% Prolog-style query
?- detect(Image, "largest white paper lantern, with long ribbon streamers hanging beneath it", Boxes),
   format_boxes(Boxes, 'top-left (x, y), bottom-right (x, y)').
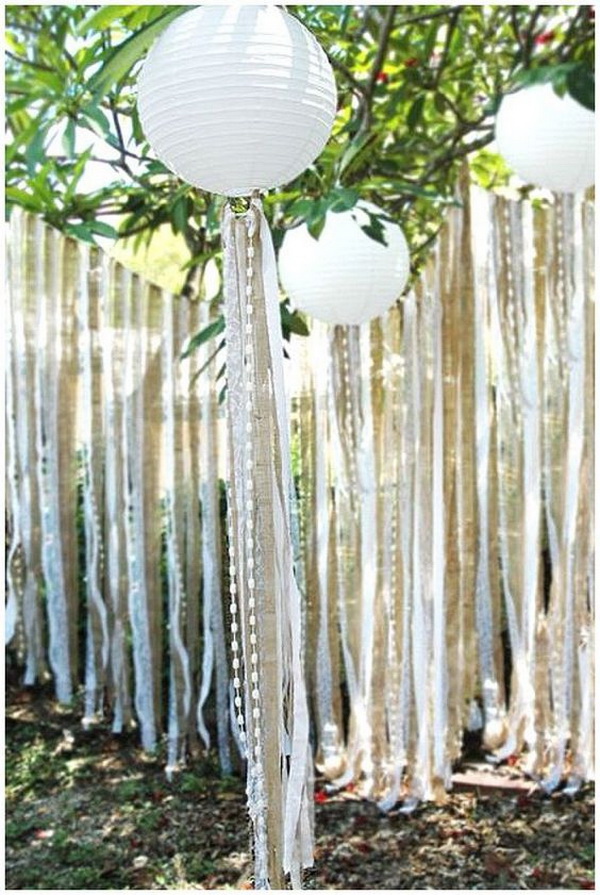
top-left (138, 5), bottom-right (336, 196)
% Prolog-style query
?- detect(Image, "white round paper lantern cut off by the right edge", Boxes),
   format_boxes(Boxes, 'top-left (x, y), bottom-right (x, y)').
top-left (496, 84), bottom-right (594, 193)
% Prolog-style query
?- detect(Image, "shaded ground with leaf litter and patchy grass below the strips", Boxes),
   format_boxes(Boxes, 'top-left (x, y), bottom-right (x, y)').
top-left (5, 687), bottom-right (594, 889)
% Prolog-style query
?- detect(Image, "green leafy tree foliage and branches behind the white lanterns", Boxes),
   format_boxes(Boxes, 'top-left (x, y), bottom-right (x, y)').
top-left (6, 5), bottom-right (594, 296)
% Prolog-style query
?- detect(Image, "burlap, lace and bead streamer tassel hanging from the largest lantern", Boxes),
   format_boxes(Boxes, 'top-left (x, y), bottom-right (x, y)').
top-left (223, 199), bottom-right (312, 888)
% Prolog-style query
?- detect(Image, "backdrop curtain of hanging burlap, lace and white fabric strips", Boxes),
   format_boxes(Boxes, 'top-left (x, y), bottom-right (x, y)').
top-left (6, 191), bottom-right (594, 811)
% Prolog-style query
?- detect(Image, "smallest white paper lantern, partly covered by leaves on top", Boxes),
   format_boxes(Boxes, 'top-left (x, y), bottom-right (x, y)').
top-left (279, 201), bottom-right (410, 325)
